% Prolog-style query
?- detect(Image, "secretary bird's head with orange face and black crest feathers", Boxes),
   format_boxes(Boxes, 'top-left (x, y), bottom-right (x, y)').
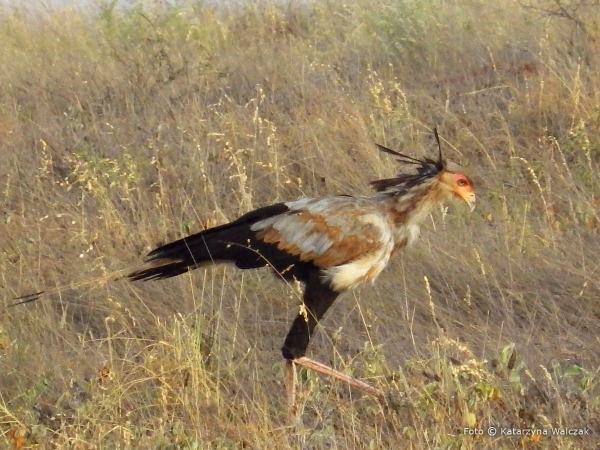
top-left (371, 129), bottom-right (476, 211)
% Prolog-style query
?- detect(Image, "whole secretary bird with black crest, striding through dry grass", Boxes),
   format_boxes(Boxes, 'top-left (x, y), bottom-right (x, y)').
top-left (11, 130), bottom-right (475, 411)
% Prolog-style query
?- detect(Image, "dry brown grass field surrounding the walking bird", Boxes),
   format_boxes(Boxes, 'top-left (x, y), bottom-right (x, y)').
top-left (0, 0), bottom-right (600, 450)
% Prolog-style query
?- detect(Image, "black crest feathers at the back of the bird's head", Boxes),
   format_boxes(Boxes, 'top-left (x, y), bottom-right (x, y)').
top-left (370, 128), bottom-right (445, 192)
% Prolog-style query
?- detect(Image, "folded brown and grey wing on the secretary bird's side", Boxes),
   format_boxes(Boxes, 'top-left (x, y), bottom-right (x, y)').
top-left (251, 196), bottom-right (393, 268)
